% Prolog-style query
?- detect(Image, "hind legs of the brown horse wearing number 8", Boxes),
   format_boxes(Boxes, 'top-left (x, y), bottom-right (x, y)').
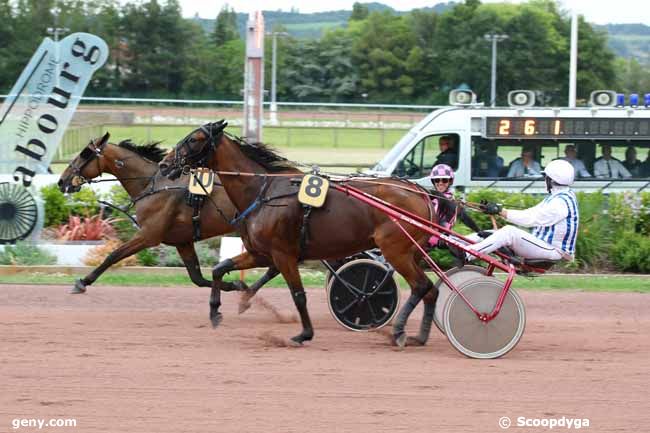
top-left (382, 248), bottom-right (438, 347)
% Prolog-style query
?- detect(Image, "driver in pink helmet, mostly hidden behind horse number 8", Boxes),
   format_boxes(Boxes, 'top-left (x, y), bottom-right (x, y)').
top-left (429, 164), bottom-right (481, 247)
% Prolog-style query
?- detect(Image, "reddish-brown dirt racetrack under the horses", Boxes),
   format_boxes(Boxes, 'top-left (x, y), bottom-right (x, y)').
top-left (0, 285), bottom-right (650, 433)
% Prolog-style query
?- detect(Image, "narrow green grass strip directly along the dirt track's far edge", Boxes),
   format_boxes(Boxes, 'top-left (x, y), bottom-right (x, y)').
top-left (2, 270), bottom-right (650, 293)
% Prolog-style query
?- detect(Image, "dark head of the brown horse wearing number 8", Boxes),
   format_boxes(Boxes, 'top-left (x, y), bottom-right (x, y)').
top-left (159, 120), bottom-right (228, 180)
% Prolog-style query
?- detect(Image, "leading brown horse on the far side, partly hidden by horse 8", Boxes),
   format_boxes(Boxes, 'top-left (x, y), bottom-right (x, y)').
top-left (58, 133), bottom-right (278, 322)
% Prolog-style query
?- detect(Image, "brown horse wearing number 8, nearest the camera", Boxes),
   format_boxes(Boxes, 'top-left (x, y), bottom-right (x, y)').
top-left (160, 121), bottom-right (438, 346)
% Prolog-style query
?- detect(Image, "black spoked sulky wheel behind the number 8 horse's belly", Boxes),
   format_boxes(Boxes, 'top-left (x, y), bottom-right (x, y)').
top-left (327, 259), bottom-right (399, 331)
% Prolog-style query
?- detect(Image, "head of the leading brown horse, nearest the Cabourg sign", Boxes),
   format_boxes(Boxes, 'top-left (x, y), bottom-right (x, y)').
top-left (58, 132), bottom-right (110, 193)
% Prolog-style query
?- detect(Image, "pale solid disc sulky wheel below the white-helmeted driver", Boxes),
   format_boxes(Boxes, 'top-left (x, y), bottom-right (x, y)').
top-left (444, 277), bottom-right (526, 359)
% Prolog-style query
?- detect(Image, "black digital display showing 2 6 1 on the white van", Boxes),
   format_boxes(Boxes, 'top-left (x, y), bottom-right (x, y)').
top-left (485, 117), bottom-right (650, 140)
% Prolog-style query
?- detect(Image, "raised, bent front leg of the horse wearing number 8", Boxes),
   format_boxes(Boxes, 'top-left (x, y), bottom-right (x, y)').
top-left (210, 252), bottom-right (268, 328)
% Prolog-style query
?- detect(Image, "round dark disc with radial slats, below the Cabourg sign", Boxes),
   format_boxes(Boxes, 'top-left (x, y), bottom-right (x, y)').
top-left (0, 182), bottom-right (38, 244)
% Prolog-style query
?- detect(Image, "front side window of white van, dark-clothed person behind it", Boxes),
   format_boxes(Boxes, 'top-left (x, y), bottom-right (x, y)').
top-left (394, 134), bottom-right (459, 179)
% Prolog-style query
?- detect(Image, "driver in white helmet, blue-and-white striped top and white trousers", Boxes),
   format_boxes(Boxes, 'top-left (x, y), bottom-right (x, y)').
top-left (466, 159), bottom-right (579, 261)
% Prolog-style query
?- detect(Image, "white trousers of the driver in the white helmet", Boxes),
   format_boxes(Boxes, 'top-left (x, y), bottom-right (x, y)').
top-left (467, 226), bottom-right (562, 260)
